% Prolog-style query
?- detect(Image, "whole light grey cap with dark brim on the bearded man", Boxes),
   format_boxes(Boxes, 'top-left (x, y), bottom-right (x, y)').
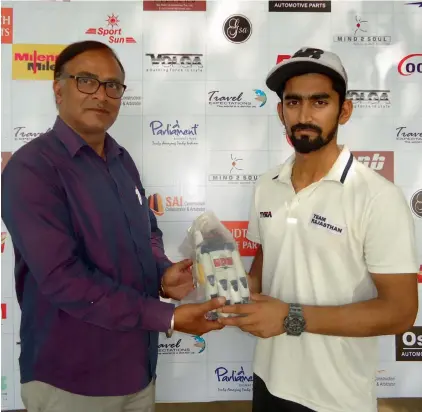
top-left (266, 47), bottom-right (347, 98)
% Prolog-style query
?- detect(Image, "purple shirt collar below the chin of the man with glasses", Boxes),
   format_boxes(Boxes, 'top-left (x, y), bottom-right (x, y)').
top-left (53, 116), bottom-right (123, 159)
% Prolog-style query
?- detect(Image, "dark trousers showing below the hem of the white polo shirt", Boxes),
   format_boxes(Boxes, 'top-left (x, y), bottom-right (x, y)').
top-left (252, 374), bottom-right (315, 412)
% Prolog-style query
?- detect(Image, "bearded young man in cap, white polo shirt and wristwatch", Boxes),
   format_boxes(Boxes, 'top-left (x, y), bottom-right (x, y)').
top-left (221, 48), bottom-right (418, 412)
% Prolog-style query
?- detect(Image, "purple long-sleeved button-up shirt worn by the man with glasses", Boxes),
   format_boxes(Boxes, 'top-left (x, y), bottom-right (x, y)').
top-left (1, 117), bottom-right (174, 396)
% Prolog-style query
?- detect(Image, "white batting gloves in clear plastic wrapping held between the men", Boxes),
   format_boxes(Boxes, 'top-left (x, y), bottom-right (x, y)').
top-left (188, 211), bottom-right (250, 317)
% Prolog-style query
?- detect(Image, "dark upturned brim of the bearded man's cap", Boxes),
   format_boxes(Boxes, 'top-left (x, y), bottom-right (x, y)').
top-left (266, 61), bottom-right (346, 94)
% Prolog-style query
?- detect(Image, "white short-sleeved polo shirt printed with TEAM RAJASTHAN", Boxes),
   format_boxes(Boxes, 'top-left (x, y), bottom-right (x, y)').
top-left (247, 147), bottom-right (419, 412)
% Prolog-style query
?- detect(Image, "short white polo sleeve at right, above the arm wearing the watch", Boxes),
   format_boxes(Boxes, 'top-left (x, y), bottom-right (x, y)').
top-left (364, 185), bottom-right (419, 274)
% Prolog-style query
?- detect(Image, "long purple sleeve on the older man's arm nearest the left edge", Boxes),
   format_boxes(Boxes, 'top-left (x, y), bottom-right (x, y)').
top-left (1, 159), bottom-right (174, 332)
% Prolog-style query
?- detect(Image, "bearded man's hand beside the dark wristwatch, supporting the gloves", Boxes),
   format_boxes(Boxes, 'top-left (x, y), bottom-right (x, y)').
top-left (218, 293), bottom-right (289, 338)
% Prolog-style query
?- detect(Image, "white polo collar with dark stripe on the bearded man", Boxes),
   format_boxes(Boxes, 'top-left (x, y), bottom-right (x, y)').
top-left (273, 145), bottom-right (353, 184)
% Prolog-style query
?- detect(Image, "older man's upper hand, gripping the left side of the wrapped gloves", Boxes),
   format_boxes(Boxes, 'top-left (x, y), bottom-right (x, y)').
top-left (163, 259), bottom-right (194, 300)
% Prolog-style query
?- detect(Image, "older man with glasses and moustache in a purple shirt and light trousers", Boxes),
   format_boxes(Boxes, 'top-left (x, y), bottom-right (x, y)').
top-left (2, 41), bottom-right (224, 412)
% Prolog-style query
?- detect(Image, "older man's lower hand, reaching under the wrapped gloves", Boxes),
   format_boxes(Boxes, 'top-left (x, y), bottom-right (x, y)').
top-left (174, 297), bottom-right (226, 336)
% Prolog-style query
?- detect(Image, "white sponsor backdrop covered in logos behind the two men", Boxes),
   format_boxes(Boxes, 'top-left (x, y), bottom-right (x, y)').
top-left (1, 0), bottom-right (422, 409)
